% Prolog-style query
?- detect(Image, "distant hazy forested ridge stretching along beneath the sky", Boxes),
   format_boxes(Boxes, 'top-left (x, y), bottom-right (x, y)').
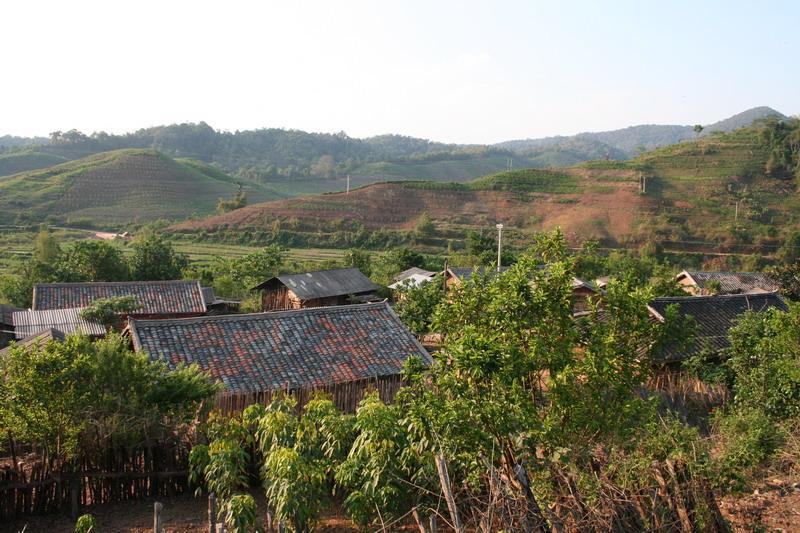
top-left (0, 107), bottom-right (783, 183)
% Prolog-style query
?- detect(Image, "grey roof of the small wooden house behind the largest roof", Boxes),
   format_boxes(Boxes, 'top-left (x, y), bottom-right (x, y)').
top-left (253, 268), bottom-right (380, 300)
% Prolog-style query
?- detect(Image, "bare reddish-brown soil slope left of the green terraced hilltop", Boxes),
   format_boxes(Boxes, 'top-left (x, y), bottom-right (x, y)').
top-left (173, 168), bottom-right (648, 240)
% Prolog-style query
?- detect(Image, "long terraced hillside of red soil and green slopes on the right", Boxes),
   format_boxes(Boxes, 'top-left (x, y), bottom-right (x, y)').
top-left (174, 119), bottom-right (800, 255)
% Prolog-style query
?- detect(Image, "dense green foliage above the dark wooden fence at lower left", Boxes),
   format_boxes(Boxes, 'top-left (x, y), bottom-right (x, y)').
top-left (0, 333), bottom-right (218, 461)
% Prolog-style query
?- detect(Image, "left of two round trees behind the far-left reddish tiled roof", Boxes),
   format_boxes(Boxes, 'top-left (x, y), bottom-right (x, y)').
top-left (56, 240), bottom-right (128, 282)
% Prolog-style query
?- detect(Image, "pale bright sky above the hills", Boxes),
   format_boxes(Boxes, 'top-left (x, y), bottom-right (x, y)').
top-left (0, 0), bottom-right (800, 143)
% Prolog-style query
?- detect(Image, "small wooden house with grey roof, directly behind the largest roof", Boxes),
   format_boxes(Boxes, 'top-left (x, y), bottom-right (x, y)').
top-left (252, 268), bottom-right (380, 311)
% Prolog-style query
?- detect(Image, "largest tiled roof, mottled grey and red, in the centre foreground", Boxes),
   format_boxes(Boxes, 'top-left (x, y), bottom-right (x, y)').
top-left (130, 302), bottom-right (431, 392)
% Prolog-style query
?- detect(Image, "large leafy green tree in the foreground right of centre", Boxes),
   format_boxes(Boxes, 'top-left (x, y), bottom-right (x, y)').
top-left (398, 232), bottom-right (660, 530)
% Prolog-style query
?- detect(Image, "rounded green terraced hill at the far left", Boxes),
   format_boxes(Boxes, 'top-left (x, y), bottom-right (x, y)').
top-left (0, 150), bottom-right (278, 227)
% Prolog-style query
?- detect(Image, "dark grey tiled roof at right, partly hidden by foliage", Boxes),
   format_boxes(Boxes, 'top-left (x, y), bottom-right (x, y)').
top-left (648, 293), bottom-right (788, 360)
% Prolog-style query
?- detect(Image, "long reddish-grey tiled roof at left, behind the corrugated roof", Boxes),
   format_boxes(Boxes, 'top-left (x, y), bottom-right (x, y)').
top-left (33, 280), bottom-right (206, 315)
